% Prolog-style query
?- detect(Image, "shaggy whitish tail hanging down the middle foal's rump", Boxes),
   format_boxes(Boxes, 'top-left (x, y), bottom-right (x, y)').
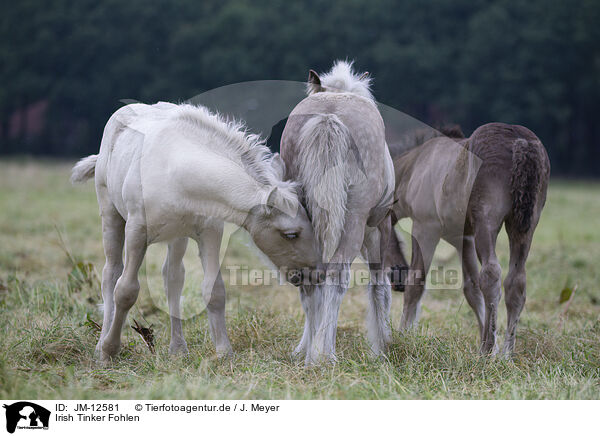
top-left (298, 114), bottom-right (351, 262)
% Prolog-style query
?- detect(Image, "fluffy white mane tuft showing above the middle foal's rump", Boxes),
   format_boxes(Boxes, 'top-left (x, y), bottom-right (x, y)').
top-left (307, 60), bottom-right (374, 100)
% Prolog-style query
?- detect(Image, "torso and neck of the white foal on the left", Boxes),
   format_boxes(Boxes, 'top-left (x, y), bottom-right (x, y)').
top-left (96, 102), bottom-right (267, 241)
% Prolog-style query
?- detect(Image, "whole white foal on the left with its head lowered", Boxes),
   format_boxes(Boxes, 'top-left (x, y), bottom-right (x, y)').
top-left (71, 103), bottom-right (321, 361)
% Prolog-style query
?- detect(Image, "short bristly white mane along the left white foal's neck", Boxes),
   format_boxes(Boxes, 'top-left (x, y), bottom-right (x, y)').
top-left (166, 103), bottom-right (297, 204)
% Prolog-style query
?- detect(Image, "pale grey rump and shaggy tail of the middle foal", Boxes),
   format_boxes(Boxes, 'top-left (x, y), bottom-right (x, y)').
top-left (282, 93), bottom-right (394, 259)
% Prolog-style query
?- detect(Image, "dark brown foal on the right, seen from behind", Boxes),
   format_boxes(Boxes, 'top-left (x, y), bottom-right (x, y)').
top-left (388, 123), bottom-right (550, 355)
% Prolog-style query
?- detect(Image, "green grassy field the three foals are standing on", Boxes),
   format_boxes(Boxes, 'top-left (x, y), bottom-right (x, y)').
top-left (0, 161), bottom-right (600, 399)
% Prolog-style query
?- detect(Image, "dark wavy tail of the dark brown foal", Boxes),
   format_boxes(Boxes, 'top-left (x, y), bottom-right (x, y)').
top-left (510, 138), bottom-right (543, 233)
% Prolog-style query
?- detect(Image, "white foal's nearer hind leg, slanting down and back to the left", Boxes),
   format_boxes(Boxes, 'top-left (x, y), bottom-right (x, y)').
top-left (102, 217), bottom-right (147, 361)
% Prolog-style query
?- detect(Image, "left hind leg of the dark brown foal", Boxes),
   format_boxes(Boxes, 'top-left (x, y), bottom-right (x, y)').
top-left (475, 221), bottom-right (502, 355)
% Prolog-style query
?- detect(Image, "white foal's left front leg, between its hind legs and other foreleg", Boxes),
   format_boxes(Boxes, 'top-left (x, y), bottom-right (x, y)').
top-left (162, 238), bottom-right (188, 354)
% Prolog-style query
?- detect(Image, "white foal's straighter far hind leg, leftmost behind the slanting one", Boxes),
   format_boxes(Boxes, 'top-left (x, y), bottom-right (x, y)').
top-left (96, 205), bottom-right (125, 357)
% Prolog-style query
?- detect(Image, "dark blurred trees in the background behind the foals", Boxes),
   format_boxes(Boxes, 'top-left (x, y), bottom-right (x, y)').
top-left (0, 0), bottom-right (600, 176)
